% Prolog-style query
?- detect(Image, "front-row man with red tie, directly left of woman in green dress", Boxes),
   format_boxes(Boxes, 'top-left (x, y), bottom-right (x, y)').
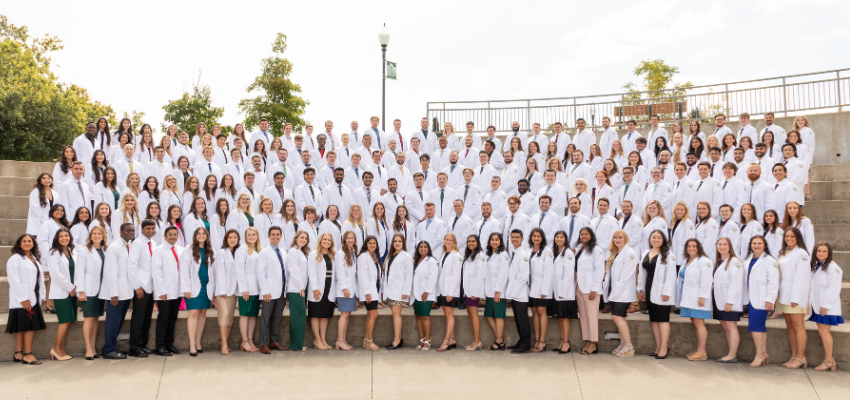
top-left (151, 226), bottom-right (183, 356)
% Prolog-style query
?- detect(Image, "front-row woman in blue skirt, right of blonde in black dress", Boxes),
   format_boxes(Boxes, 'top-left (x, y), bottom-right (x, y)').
top-left (334, 231), bottom-right (359, 350)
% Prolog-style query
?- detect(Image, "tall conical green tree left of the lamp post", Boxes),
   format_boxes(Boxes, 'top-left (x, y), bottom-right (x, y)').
top-left (239, 33), bottom-right (310, 135)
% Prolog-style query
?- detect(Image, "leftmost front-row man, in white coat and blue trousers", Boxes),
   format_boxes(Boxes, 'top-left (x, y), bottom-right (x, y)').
top-left (98, 222), bottom-right (135, 360)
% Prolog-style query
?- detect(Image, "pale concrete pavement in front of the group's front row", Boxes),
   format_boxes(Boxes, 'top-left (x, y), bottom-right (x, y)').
top-left (0, 347), bottom-right (850, 400)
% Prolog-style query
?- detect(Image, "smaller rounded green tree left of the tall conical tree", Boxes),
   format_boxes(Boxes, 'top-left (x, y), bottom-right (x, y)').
top-left (161, 78), bottom-right (231, 137)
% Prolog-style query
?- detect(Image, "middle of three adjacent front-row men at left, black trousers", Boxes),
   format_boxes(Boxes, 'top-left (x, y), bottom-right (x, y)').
top-left (127, 219), bottom-right (156, 357)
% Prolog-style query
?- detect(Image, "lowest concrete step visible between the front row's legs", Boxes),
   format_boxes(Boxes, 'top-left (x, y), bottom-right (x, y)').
top-left (0, 307), bottom-right (850, 362)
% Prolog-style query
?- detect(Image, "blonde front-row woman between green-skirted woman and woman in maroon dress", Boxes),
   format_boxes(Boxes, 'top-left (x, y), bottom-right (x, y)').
top-left (437, 233), bottom-right (464, 351)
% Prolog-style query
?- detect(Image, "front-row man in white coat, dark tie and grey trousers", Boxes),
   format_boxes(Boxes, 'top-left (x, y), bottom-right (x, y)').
top-left (257, 226), bottom-right (288, 354)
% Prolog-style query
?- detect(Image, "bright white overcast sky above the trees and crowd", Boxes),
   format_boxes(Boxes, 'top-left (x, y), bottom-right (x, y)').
top-left (6, 0), bottom-right (850, 139)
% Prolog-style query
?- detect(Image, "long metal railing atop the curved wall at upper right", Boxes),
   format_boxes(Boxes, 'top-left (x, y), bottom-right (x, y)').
top-left (426, 68), bottom-right (850, 132)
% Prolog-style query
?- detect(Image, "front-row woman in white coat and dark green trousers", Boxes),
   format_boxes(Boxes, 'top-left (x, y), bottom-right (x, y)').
top-left (286, 231), bottom-right (310, 351)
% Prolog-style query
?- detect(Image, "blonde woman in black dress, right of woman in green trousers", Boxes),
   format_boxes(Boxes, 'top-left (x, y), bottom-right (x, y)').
top-left (307, 233), bottom-right (336, 350)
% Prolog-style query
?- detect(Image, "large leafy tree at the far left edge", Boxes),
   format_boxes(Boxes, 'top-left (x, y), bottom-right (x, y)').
top-left (0, 15), bottom-right (115, 161)
